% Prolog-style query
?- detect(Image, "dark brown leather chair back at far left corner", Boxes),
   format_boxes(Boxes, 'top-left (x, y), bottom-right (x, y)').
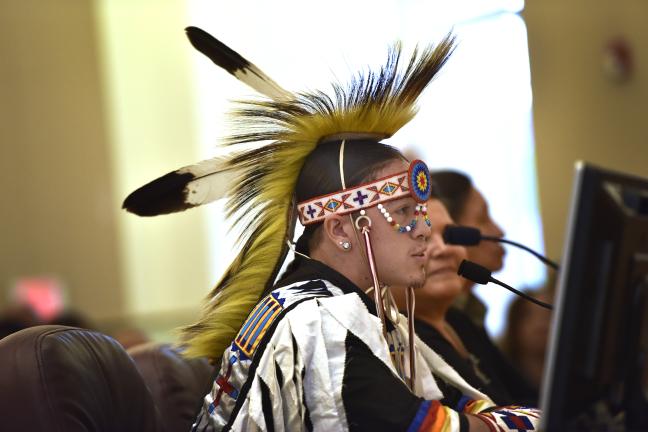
top-left (0, 326), bottom-right (163, 432)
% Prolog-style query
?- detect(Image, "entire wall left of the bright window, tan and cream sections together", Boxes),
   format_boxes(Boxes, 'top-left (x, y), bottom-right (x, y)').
top-left (0, 0), bottom-right (213, 339)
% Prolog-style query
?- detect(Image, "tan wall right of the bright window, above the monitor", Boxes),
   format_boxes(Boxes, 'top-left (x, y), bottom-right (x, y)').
top-left (524, 0), bottom-right (648, 257)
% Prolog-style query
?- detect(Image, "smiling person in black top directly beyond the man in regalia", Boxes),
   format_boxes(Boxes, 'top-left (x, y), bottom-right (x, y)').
top-left (391, 199), bottom-right (538, 406)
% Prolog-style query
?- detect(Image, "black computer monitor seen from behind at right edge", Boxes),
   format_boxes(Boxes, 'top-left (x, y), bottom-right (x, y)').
top-left (540, 162), bottom-right (648, 431)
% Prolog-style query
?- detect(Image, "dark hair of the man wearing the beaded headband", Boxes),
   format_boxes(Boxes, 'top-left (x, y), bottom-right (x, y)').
top-left (281, 140), bottom-right (404, 279)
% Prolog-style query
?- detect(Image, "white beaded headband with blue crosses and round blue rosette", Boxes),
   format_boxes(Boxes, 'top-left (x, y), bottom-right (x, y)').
top-left (297, 159), bottom-right (431, 225)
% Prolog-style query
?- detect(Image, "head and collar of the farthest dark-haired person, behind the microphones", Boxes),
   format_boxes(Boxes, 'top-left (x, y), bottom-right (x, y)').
top-left (432, 170), bottom-right (506, 327)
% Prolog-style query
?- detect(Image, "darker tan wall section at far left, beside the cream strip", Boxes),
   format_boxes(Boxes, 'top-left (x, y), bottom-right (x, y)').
top-left (0, 0), bottom-right (125, 319)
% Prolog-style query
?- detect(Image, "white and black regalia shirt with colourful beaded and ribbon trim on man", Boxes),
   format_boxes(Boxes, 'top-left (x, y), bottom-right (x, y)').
top-left (193, 260), bottom-right (536, 432)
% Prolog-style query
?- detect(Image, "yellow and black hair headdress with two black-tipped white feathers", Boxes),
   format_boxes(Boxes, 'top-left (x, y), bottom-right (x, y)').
top-left (124, 27), bottom-right (454, 358)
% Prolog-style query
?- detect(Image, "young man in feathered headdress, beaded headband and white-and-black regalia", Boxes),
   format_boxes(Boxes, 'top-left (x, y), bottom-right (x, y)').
top-left (124, 28), bottom-right (538, 431)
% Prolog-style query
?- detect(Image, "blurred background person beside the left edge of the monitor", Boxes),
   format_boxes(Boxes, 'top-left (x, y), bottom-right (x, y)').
top-left (499, 278), bottom-right (554, 391)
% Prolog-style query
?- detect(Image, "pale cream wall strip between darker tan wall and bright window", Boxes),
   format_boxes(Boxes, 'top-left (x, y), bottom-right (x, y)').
top-left (95, 0), bottom-right (215, 336)
